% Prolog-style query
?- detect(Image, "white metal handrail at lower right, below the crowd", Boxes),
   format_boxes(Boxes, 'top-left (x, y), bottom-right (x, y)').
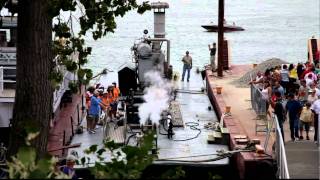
top-left (272, 113), bottom-right (290, 179)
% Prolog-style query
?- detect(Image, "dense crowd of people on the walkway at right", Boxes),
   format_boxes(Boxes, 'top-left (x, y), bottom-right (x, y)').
top-left (249, 61), bottom-right (320, 143)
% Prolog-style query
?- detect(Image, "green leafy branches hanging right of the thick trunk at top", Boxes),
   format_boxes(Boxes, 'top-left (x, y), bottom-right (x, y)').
top-left (48, 0), bottom-right (151, 90)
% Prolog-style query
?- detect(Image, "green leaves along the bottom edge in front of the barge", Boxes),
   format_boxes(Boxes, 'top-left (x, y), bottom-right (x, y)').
top-left (6, 131), bottom-right (185, 179)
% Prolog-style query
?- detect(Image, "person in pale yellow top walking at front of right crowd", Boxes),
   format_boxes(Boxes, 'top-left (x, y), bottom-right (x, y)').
top-left (299, 102), bottom-right (313, 140)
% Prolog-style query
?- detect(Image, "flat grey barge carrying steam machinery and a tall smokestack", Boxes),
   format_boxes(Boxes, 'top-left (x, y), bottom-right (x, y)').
top-left (68, 2), bottom-right (236, 178)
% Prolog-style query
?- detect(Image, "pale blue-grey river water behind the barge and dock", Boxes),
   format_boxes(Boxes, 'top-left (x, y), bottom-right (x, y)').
top-left (81, 0), bottom-right (320, 73)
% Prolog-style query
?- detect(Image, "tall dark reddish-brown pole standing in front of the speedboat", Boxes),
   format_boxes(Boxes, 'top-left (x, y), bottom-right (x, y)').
top-left (218, 0), bottom-right (224, 77)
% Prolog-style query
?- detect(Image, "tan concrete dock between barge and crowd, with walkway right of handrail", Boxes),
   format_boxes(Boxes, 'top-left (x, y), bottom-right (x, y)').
top-left (206, 65), bottom-right (319, 179)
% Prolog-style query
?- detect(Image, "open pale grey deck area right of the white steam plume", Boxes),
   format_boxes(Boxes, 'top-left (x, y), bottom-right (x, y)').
top-left (156, 71), bottom-right (230, 167)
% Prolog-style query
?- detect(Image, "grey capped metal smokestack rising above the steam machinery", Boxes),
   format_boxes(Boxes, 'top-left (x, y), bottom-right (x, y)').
top-left (151, 1), bottom-right (169, 38)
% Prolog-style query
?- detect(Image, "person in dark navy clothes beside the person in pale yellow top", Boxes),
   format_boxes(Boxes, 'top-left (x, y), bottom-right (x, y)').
top-left (286, 93), bottom-right (302, 141)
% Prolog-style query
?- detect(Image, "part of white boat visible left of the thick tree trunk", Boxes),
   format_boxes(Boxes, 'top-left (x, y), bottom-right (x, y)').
top-left (0, 16), bottom-right (17, 148)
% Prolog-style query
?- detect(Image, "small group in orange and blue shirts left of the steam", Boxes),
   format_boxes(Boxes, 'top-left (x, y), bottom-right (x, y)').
top-left (86, 82), bottom-right (120, 134)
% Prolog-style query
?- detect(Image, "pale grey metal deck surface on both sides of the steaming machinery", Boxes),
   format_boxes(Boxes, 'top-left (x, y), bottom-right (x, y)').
top-left (69, 70), bottom-right (229, 167)
